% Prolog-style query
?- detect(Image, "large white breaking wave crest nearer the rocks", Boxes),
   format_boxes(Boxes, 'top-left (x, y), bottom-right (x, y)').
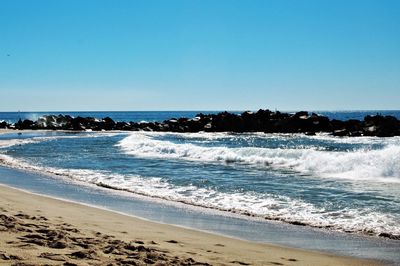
top-left (117, 132), bottom-right (400, 183)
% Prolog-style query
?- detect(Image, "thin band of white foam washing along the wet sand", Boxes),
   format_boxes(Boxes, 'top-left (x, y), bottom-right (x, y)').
top-left (0, 154), bottom-right (400, 235)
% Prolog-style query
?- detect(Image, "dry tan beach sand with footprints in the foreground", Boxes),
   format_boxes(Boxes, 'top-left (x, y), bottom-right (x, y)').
top-left (0, 185), bottom-right (377, 265)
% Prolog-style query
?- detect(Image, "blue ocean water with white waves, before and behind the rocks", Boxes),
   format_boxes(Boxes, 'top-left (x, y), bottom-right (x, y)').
top-left (0, 111), bottom-right (400, 262)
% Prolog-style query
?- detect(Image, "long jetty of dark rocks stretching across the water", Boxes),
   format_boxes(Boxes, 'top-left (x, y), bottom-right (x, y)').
top-left (0, 109), bottom-right (400, 137)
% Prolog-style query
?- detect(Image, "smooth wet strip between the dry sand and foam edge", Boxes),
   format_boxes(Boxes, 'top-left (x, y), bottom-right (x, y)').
top-left (0, 167), bottom-right (400, 265)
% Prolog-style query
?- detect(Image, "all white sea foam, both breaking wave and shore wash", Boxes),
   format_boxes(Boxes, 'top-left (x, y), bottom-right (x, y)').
top-left (0, 132), bottom-right (400, 238)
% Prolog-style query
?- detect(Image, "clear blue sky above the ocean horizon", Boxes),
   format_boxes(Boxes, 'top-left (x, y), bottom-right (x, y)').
top-left (0, 0), bottom-right (400, 111)
